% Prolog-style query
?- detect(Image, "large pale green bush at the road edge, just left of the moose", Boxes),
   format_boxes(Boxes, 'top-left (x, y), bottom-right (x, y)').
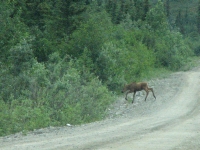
top-left (45, 53), bottom-right (113, 124)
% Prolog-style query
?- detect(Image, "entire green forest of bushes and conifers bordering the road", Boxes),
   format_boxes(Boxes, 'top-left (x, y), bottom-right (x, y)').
top-left (0, 0), bottom-right (200, 136)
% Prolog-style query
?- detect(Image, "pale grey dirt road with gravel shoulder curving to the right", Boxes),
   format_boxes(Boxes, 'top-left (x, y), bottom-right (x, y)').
top-left (0, 68), bottom-right (200, 150)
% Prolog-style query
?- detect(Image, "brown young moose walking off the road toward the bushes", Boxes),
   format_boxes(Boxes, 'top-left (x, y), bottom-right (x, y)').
top-left (122, 82), bottom-right (156, 103)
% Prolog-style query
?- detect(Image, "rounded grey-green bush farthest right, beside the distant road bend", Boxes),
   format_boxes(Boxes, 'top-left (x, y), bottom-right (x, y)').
top-left (155, 31), bottom-right (193, 70)
